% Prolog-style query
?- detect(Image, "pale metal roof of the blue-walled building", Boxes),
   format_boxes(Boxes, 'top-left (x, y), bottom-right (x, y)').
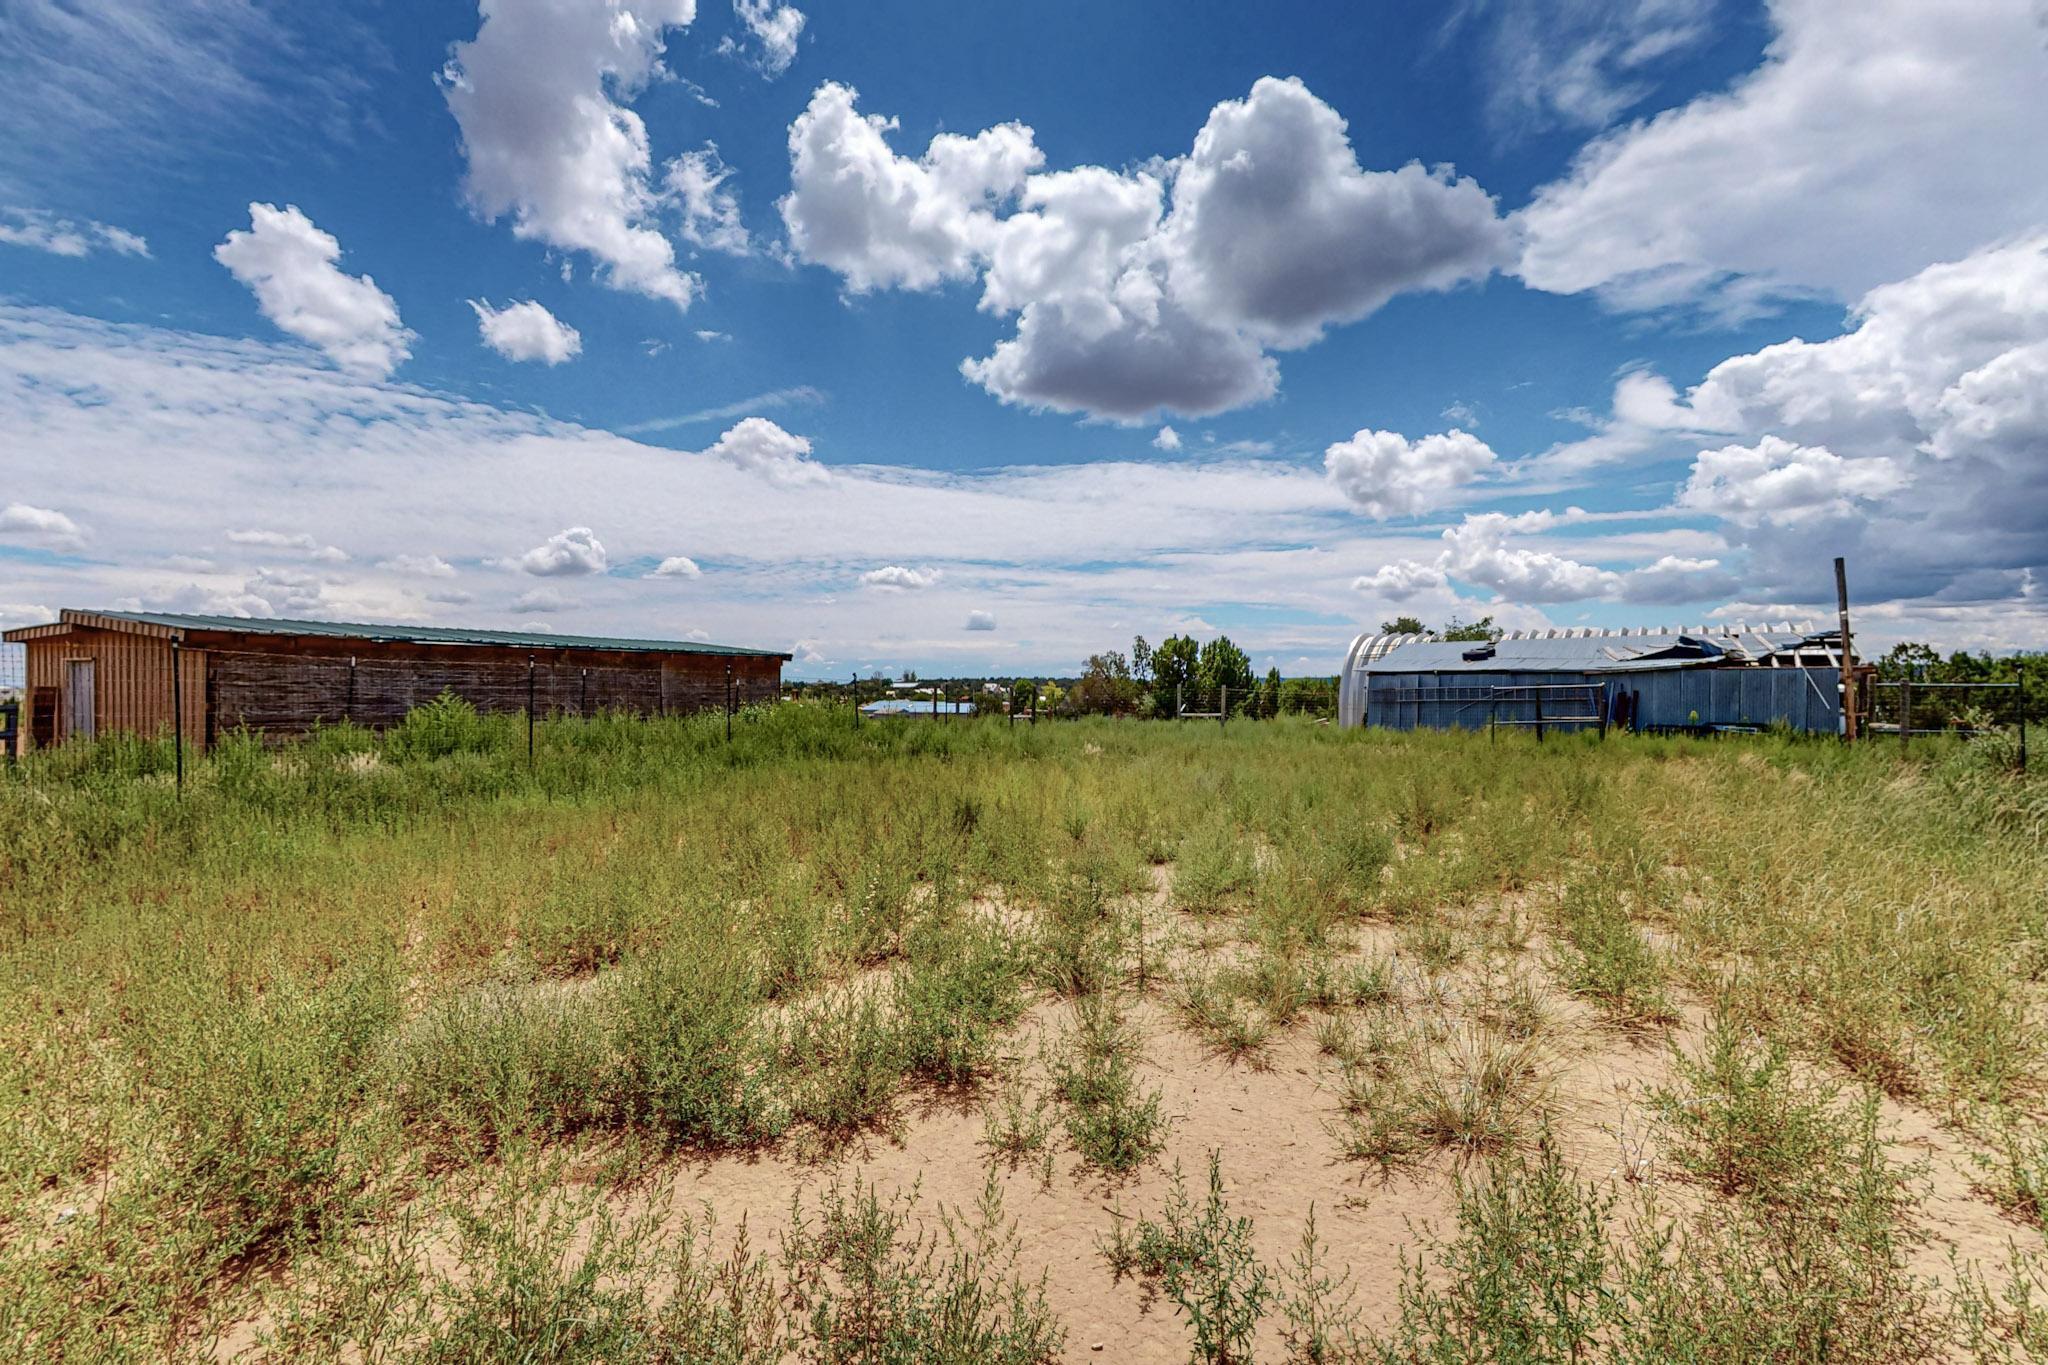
top-left (1364, 630), bottom-right (1806, 675)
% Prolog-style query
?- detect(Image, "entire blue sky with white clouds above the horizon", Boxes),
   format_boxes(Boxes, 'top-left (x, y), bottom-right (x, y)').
top-left (0, 0), bottom-right (2048, 675)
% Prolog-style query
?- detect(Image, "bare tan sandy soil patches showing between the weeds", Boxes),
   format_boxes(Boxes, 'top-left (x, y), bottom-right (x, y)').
top-left (207, 886), bottom-right (2019, 1363)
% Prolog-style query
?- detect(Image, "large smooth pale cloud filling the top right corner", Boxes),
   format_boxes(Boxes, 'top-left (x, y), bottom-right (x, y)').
top-left (1518, 0), bottom-right (2048, 311)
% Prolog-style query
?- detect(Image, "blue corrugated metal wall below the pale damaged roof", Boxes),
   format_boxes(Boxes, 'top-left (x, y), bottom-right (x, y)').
top-left (1366, 667), bottom-right (1841, 735)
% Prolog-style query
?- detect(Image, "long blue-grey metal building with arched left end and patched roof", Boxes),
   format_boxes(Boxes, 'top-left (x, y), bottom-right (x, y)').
top-left (1337, 624), bottom-right (1841, 735)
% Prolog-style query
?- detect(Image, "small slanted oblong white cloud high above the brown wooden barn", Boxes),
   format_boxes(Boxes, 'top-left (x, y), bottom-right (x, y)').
top-left (213, 205), bottom-right (414, 379)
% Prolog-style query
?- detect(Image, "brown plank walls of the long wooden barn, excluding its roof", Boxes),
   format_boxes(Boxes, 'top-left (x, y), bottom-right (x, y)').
top-left (10, 620), bottom-right (782, 749)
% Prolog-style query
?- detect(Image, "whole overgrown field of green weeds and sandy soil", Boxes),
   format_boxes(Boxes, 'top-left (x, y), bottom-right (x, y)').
top-left (0, 704), bottom-right (2048, 1365)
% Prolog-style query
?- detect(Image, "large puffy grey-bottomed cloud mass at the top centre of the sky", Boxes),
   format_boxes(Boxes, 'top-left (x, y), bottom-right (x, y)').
top-left (780, 78), bottom-right (1507, 422)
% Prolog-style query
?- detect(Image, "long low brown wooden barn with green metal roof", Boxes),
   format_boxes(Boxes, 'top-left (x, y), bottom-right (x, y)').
top-left (4, 610), bottom-right (788, 749)
